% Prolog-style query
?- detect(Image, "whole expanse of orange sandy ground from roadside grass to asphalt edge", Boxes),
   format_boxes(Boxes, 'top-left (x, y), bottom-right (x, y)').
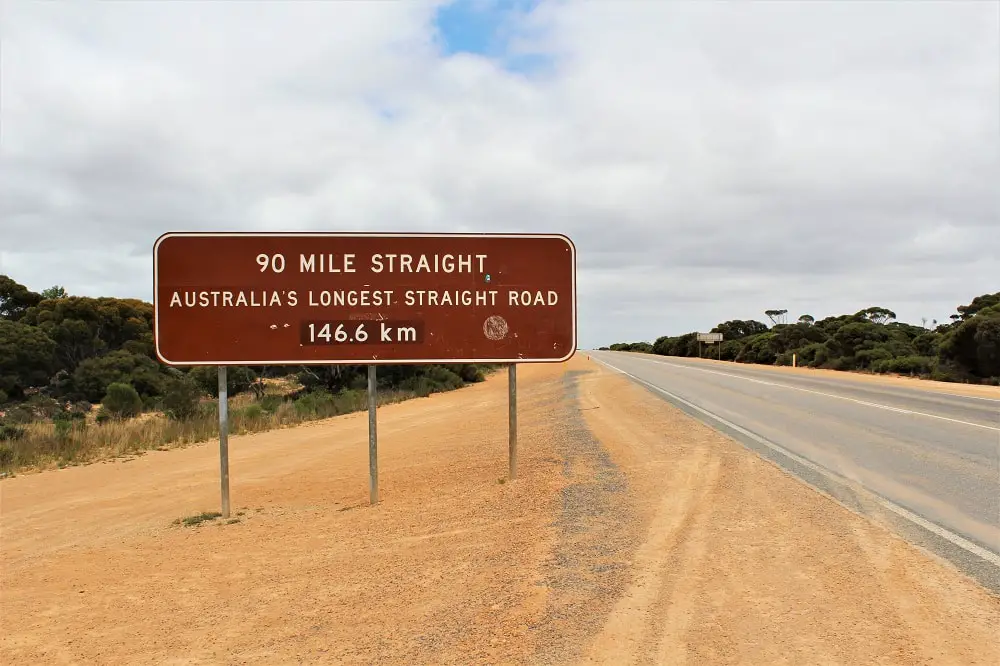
top-left (0, 356), bottom-right (1000, 665)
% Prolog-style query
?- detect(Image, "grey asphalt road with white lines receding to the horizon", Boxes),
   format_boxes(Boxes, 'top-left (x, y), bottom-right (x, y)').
top-left (591, 352), bottom-right (1000, 578)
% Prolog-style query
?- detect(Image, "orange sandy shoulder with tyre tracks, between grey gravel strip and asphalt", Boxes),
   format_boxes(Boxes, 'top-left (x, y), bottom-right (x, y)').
top-left (580, 364), bottom-right (1000, 664)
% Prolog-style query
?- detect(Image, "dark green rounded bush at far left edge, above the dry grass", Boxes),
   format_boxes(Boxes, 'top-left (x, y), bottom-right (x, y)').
top-left (0, 319), bottom-right (56, 400)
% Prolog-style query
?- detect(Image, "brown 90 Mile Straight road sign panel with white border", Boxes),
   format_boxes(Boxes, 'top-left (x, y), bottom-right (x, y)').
top-left (153, 233), bottom-right (576, 365)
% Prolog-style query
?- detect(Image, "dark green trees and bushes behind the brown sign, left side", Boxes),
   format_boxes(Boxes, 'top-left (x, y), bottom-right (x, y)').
top-left (0, 275), bottom-right (490, 418)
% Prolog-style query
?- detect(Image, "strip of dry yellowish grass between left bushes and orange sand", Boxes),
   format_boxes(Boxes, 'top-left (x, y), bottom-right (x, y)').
top-left (0, 384), bottom-right (426, 474)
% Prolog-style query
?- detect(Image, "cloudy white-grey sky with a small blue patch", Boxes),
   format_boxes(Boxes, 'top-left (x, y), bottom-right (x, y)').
top-left (0, 0), bottom-right (1000, 349)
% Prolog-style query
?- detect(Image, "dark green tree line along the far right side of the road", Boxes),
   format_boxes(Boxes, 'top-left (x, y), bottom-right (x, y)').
top-left (602, 292), bottom-right (1000, 385)
